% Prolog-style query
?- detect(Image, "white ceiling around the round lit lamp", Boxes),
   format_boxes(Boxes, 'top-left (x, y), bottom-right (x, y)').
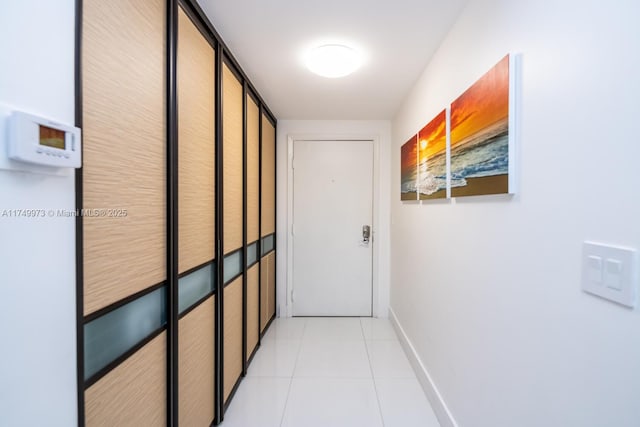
top-left (198, 0), bottom-right (467, 120)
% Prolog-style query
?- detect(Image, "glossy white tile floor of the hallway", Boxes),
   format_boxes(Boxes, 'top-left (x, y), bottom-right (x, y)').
top-left (221, 317), bottom-right (439, 427)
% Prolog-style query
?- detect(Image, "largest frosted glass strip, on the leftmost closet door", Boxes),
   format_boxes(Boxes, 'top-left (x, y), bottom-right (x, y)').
top-left (84, 286), bottom-right (167, 380)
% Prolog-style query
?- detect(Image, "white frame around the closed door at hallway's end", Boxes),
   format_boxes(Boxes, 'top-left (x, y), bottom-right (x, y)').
top-left (280, 133), bottom-right (386, 317)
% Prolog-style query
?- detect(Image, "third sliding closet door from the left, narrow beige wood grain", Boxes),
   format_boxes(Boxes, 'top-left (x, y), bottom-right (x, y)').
top-left (222, 63), bottom-right (244, 403)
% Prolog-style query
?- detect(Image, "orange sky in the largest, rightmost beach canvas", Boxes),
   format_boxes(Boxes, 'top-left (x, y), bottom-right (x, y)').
top-left (451, 56), bottom-right (509, 147)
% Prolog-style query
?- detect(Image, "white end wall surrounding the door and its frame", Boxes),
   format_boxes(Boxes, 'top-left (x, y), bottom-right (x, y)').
top-left (276, 120), bottom-right (391, 317)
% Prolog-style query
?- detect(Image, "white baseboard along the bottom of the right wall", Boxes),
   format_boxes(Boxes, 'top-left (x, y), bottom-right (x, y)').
top-left (389, 307), bottom-right (458, 427)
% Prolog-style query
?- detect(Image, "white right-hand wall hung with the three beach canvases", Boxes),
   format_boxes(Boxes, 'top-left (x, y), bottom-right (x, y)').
top-left (391, 0), bottom-right (640, 427)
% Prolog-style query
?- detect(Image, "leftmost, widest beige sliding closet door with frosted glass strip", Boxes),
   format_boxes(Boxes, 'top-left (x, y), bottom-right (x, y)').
top-left (81, 0), bottom-right (167, 426)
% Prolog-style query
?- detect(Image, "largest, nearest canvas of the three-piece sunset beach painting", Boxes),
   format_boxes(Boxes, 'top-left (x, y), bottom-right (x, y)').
top-left (451, 55), bottom-right (513, 197)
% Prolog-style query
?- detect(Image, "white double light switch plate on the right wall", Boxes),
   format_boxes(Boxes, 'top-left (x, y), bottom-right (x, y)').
top-left (582, 242), bottom-right (638, 308)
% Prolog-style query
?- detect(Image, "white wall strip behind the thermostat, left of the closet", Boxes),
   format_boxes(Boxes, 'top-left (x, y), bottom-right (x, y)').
top-left (0, 0), bottom-right (77, 427)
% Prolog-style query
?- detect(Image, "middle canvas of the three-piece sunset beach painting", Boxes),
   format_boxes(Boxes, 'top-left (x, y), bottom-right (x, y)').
top-left (417, 110), bottom-right (447, 200)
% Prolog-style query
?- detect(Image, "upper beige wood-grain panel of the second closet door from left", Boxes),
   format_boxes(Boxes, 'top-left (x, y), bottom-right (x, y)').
top-left (178, 9), bottom-right (215, 273)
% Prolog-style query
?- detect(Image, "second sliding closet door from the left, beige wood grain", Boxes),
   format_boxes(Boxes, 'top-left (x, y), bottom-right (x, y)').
top-left (177, 9), bottom-right (215, 427)
